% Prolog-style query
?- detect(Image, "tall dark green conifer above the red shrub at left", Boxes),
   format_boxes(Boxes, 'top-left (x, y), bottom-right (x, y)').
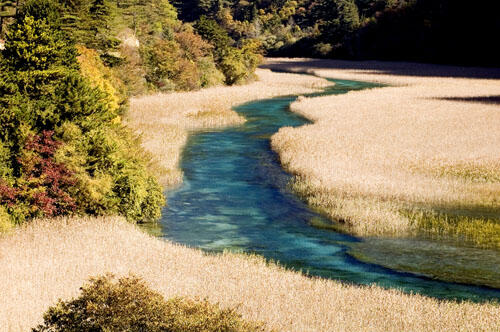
top-left (0, 0), bottom-right (113, 147)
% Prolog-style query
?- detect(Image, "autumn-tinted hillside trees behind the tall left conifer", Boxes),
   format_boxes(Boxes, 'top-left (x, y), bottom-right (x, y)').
top-left (0, 0), bottom-right (262, 94)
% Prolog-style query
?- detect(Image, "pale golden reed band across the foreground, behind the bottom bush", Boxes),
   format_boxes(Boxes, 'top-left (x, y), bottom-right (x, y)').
top-left (0, 218), bottom-right (500, 332)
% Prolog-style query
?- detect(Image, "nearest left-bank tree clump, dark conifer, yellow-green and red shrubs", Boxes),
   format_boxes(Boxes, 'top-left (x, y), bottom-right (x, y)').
top-left (0, 0), bottom-right (164, 228)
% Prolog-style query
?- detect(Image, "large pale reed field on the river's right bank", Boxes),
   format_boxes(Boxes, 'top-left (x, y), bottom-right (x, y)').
top-left (266, 59), bottom-right (500, 248)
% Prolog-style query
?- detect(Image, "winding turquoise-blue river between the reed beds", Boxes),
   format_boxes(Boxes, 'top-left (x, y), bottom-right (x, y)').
top-left (161, 80), bottom-right (500, 301)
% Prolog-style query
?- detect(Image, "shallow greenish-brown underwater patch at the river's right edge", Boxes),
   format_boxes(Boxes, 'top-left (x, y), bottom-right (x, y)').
top-left (349, 238), bottom-right (500, 288)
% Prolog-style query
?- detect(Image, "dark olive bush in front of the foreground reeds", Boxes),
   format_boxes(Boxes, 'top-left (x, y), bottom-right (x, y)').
top-left (32, 275), bottom-right (264, 332)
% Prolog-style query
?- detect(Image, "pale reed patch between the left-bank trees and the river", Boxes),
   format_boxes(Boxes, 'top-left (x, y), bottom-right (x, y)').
top-left (127, 69), bottom-right (330, 186)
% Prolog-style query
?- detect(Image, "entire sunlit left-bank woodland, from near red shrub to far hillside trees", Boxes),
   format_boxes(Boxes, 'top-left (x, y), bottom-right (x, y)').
top-left (0, 0), bottom-right (261, 229)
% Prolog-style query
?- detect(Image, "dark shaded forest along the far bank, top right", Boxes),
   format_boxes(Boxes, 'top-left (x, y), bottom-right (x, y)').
top-left (174, 0), bottom-right (500, 66)
